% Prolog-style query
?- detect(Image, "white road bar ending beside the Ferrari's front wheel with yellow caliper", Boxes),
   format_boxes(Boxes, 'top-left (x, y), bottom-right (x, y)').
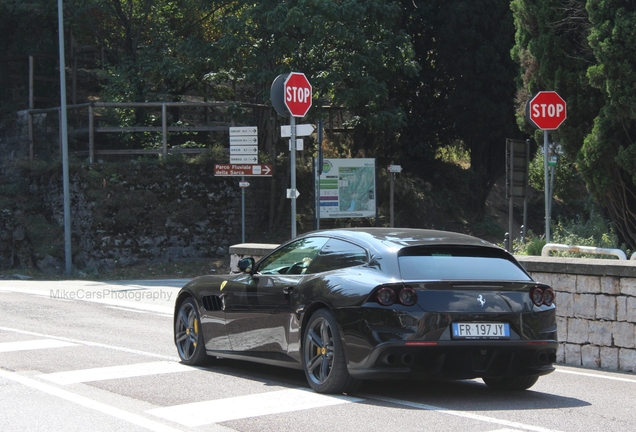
top-left (37, 361), bottom-right (197, 385)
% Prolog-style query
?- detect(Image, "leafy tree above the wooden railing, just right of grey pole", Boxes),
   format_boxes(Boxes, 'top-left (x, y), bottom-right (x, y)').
top-left (69, 0), bottom-right (222, 101)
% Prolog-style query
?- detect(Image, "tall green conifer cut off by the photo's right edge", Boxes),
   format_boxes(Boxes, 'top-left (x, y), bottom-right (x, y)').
top-left (580, 0), bottom-right (636, 248)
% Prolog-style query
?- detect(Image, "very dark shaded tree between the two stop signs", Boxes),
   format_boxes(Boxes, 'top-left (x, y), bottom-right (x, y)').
top-left (402, 0), bottom-right (518, 214)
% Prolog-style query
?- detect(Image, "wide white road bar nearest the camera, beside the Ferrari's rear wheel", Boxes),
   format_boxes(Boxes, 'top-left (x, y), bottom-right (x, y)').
top-left (146, 389), bottom-right (363, 427)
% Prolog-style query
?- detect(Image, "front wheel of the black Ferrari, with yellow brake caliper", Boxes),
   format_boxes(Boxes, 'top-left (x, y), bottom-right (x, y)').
top-left (174, 297), bottom-right (207, 366)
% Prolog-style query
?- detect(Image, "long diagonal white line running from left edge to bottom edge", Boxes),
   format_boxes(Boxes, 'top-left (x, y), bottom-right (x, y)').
top-left (0, 369), bottom-right (191, 432)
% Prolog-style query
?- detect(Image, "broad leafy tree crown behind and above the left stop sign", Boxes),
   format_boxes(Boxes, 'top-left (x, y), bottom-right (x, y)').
top-left (215, 0), bottom-right (417, 156)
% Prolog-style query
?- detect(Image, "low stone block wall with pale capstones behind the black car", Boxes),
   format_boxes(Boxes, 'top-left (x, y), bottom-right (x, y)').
top-left (230, 244), bottom-right (636, 372)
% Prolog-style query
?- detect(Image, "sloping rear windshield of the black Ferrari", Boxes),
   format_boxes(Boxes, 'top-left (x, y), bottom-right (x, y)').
top-left (398, 246), bottom-right (531, 281)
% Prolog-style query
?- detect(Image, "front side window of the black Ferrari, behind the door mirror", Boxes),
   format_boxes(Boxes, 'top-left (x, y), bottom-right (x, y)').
top-left (257, 237), bottom-right (329, 274)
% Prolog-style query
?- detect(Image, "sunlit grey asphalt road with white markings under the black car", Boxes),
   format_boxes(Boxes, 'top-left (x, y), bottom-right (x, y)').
top-left (0, 280), bottom-right (636, 432)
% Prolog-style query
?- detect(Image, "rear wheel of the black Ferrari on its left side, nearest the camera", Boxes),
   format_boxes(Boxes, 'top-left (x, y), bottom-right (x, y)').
top-left (302, 309), bottom-right (361, 394)
